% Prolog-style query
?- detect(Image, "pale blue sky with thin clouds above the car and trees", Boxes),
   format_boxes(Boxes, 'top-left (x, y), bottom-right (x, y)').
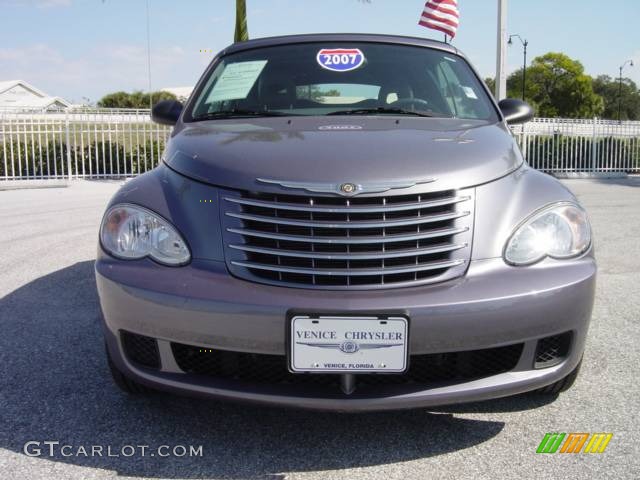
top-left (0, 0), bottom-right (640, 103)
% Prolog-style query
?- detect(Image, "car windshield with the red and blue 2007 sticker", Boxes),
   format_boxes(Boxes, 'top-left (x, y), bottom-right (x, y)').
top-left (186, 42), bottom-right (497, 121)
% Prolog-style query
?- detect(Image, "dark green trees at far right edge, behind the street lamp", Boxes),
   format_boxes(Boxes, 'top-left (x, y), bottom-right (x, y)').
top-left (593, 75), bottom-right (640, 120)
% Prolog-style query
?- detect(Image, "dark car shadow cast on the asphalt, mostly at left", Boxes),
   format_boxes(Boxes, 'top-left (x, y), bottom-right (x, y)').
top-left (0, 262), bottom-right (543, 479)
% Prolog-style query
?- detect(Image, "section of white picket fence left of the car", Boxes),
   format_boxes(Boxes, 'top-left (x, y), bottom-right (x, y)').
top-left (0, 109), bottom-right (171, 180)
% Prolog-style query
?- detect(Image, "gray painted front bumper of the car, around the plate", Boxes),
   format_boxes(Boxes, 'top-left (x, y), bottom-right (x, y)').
top-left (96, 253), bottom-right (596, 411)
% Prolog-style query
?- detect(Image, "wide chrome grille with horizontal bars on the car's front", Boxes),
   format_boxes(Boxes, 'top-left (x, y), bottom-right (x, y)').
top-left (222, 190), bottom-right (474, 289)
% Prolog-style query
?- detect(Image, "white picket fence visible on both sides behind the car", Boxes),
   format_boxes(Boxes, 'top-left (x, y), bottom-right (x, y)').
top-left (0, 109), bottom-right (640, 181)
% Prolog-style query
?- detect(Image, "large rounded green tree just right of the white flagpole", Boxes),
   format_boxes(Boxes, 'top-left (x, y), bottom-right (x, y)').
top-left (507, 52), bottom-right (604, 118)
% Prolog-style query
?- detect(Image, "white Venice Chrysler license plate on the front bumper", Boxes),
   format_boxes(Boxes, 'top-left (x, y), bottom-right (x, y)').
top-left (290, 316), bottom-right (409, 373)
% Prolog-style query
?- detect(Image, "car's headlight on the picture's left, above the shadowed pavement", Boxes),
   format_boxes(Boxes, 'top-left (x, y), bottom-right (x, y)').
top-left (100, 205), bottom-right (191, 266)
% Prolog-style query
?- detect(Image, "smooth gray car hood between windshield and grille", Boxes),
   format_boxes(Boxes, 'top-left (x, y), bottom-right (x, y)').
top-left (164, 116), bottom-right (523, 193)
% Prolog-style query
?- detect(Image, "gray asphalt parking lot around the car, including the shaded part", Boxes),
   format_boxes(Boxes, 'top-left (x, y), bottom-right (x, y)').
top-left (0, 178), bottom-right (640, 479)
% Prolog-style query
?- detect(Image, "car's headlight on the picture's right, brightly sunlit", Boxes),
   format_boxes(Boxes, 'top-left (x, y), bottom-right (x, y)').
top-left (504, 203), bottom-right (591, 265)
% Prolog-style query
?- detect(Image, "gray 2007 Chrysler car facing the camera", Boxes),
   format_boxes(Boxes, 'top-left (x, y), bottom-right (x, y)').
top-left (95, 34), bottom-right (596, 411)
